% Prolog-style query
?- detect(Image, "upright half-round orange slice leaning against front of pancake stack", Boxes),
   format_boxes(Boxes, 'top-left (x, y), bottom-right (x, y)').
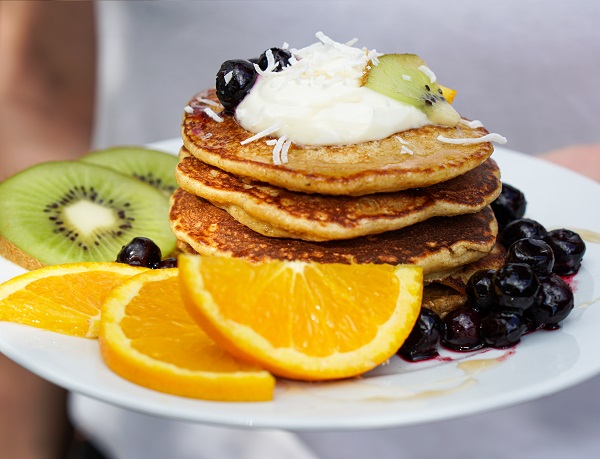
top-left (179, 255), bottom-right (423, 380)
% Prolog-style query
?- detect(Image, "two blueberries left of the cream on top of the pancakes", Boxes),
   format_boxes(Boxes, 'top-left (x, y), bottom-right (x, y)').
top-left (216, 48), bottom-right (292, 112)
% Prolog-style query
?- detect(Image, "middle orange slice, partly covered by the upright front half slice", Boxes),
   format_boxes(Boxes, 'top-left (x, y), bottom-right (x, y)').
top-left (99, 269), bottom-right (275, 401)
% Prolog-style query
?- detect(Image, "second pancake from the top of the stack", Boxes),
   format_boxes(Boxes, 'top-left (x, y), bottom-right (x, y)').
top-left (175, 148), bottom-right (502, 241)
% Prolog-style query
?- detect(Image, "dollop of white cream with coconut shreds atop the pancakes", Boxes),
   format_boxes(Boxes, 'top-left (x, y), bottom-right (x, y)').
top-left (235, 32), bottom-right (431, 145)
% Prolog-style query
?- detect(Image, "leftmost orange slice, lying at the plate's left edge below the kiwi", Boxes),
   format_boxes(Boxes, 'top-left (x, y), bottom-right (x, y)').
top-left (0, 262), bottom-right (147, 338)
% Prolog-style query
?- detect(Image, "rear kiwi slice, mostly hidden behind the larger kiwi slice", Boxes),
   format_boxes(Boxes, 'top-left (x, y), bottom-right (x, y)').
top-left (81, 146), bottom-right (178, 196)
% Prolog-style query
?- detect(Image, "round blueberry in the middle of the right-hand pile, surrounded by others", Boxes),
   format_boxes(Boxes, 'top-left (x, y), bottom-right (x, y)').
top-left (492, 263), bottom-right (539, 311)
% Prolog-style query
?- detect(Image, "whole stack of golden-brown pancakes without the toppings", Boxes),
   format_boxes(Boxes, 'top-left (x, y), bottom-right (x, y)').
top-left (170, 91), bottom-right (504, 315)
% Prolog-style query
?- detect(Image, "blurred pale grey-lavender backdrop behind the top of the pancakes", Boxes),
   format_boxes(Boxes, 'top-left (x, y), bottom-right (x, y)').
top-left (95, 0), bottom-right (600, 153)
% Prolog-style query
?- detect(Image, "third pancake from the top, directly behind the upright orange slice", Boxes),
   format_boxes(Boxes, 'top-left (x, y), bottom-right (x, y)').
top-left (169, 189), bottom-right (497, 274)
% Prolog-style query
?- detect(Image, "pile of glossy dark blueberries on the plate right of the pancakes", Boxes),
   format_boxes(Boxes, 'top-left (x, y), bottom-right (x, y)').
top-left (398, 184), bottom-right (585, 361)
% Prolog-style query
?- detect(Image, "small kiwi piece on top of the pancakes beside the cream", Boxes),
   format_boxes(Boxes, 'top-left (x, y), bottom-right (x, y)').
top-left (363, 54), bottom-right (460, 126)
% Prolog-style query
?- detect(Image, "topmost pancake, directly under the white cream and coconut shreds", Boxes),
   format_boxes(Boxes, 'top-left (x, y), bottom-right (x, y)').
top-left (182, 91), bottom-right (493, 196)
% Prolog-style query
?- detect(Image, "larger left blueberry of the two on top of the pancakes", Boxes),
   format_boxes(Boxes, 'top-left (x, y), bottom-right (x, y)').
top-left (216, 59), bottom-right (257, 111)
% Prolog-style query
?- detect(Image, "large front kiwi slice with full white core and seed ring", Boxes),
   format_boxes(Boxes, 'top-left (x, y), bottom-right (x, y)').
top-left (0, 161), bottom-right (176, 265)
